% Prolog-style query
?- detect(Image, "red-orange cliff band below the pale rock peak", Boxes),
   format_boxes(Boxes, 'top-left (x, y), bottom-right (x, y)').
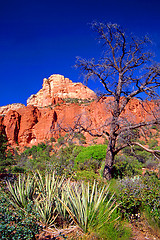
top-left (0, 98), bottom-right (158, 146)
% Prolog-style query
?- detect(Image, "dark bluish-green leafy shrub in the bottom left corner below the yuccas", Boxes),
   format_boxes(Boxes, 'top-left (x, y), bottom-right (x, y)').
top-left (0, 192), bottom-right (41, 240)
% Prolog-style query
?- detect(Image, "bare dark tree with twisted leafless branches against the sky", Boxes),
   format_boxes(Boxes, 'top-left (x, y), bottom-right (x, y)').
top-left (76, 22), bottom-right (160, 179)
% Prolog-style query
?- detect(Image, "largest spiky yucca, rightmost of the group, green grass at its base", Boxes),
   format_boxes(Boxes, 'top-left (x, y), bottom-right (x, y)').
top-left (59, 181), bottom-right (118, 233)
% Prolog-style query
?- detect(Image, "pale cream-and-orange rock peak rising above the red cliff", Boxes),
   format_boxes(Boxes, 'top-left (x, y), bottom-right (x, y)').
top-left (27, 74), bottom-right (96, 107)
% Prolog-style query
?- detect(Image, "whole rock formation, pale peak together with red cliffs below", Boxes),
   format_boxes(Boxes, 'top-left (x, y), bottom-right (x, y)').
top-left (0, 75), bottom-right (159, 146)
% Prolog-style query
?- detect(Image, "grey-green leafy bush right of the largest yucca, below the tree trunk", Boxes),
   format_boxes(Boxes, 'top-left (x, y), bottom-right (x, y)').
top-left (117, 174), bottom-right (160, 226)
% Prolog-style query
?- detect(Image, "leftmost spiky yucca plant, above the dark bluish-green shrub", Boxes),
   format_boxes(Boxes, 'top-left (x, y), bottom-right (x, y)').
top-left (7, 175), bottom-right (36, 209)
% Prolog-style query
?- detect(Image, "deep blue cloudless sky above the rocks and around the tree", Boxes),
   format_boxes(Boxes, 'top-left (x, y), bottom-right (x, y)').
top-left (0, 0), bottom-right (160, 106)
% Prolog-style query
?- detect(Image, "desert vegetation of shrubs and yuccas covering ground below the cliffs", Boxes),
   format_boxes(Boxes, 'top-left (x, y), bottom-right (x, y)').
top-left (0, 130), bottom-right (160, 240)
